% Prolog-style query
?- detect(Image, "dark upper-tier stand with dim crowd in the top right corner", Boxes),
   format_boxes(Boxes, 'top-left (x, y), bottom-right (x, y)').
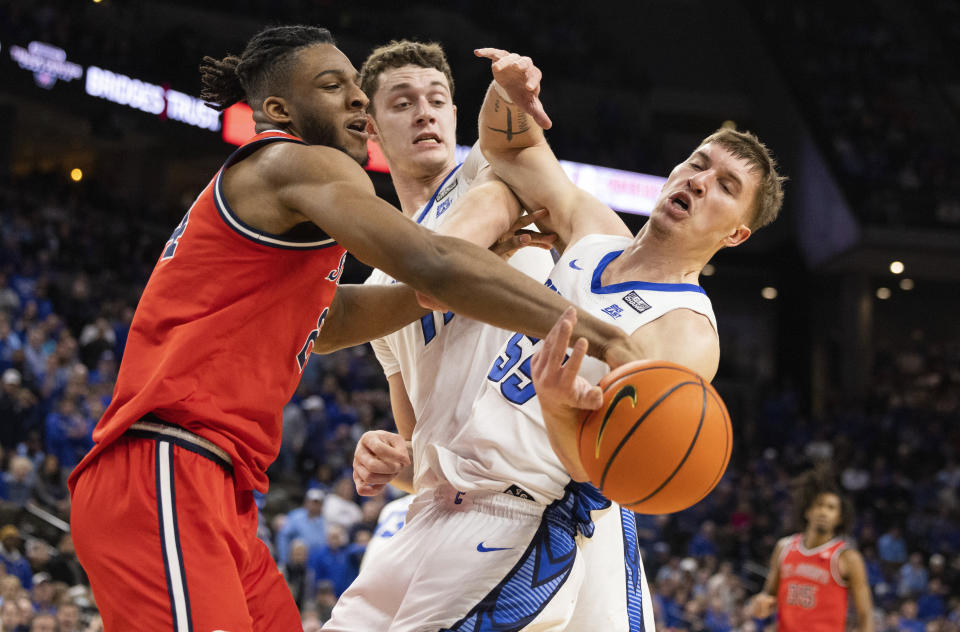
top-left (746, 0), bottom-right (960, 227)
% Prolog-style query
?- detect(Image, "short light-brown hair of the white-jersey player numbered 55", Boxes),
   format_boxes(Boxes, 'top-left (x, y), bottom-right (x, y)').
top-left (700, 127), bottom-right (787, 230)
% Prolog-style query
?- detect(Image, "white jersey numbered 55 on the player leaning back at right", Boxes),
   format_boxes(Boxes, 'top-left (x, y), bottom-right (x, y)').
top-left (425, 235), bottom-right (717, 503)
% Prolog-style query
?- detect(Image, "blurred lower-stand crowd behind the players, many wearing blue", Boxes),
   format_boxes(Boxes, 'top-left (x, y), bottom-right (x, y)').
top-left (0, 162), bottom-right (960, 632)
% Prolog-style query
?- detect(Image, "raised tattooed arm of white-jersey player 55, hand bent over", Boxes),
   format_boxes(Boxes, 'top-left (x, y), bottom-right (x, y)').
top-left (476, 48), bottom-right (630, 244)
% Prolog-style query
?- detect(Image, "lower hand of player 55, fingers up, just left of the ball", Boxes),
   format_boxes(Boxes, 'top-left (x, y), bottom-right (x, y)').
top-left (531, 307), bottom-right (603, 410)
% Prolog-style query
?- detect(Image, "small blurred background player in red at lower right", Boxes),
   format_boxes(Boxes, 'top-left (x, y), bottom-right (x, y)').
top-left (748, 471), bottom-right (874, 632)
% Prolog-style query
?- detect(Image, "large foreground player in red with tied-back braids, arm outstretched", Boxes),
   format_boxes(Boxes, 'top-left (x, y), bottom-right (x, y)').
top-left (70, 26), bottom-right (632, 632)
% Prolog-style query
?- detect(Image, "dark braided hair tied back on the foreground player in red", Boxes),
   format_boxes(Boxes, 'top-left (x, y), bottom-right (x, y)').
top-left (200, 25), bottom-right (336, 111)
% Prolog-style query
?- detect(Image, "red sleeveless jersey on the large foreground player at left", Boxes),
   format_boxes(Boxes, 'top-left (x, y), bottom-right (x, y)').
top-left (71, 131), bottom-right (346, 491)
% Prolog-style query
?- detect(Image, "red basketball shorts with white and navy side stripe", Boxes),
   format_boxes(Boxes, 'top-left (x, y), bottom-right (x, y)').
top-left (71, 436), bottom-right (302, 632)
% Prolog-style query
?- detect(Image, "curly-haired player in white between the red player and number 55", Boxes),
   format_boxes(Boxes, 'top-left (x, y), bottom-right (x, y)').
top-left (328, 41), bottom-right (554, 584)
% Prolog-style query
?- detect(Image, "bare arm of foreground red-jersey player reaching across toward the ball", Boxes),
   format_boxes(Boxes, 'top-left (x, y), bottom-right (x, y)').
top-left (262, 143), bottom-right (631, 366)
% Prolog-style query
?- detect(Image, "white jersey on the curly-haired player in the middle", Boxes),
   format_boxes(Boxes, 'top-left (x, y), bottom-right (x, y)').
top-left (366, 146), bottom-right (554, 490)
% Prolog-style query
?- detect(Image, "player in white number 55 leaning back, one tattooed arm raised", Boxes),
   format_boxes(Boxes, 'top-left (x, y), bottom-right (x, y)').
top-left (333, 51), bottom-right (782, 631)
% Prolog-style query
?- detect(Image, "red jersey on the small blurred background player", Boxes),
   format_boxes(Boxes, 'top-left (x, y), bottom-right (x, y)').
top-left (777, 533), bottom-right (848, 632)
